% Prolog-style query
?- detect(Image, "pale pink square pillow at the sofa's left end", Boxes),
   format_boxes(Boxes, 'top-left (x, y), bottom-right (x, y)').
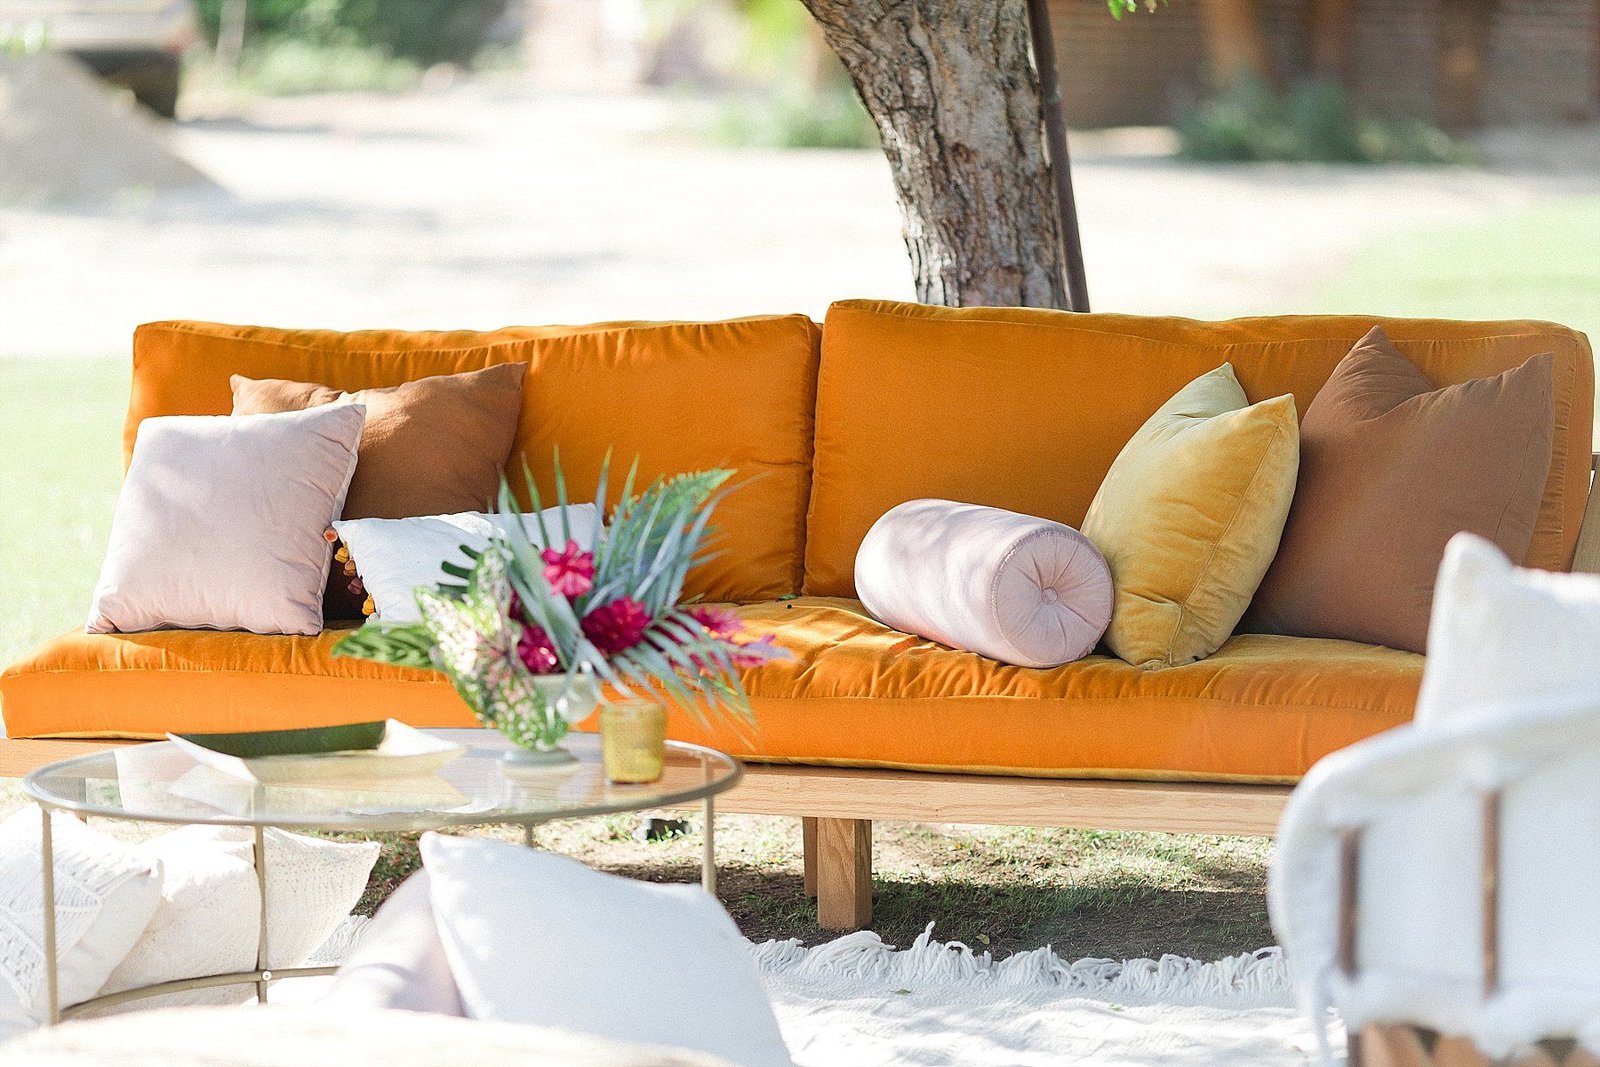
top-left (86, 405), bottom-right (366, 635)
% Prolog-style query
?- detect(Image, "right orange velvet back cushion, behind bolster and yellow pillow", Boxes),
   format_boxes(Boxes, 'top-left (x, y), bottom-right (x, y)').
top-left (805, 301), bottom-right (1594, 597)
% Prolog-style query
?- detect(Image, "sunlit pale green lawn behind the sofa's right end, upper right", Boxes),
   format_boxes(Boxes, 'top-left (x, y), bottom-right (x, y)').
top-left (1309, 197), bottom-right (1600, 341)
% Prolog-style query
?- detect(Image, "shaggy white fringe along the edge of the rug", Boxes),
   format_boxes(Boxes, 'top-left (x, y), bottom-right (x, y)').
top-left (750, 923), bottom-right (1291, 1006)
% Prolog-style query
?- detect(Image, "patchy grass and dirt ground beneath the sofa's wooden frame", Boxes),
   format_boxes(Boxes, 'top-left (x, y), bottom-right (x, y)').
top-left (409, 816), bottom-right (1275, 960)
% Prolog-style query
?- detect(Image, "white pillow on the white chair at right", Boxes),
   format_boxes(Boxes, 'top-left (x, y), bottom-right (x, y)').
top-left (1416, 533), bottom-right (1600, 728)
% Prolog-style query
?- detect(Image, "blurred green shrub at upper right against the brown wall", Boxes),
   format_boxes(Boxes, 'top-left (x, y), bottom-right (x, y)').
top-left (1178, 78), bottom-right (1472, 163)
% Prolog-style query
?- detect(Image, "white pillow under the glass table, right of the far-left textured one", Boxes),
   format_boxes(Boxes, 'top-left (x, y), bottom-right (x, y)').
top-left (101, 827), bottom-right (379, 1008)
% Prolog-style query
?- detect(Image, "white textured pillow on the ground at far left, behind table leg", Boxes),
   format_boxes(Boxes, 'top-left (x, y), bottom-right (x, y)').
top-left (0, 808), bottom-right (162, 1040)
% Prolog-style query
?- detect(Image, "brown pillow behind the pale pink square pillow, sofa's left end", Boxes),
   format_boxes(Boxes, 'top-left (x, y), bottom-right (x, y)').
top-left (229, 363), bottom-right (528, 518)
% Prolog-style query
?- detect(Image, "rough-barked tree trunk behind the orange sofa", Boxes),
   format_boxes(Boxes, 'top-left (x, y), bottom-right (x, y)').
top-left (803, 0), bottom-right (1069, 307)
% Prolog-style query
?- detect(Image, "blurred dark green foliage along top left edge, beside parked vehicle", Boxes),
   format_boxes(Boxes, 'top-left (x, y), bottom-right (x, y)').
top-left (195, 0), bottom-right (509, 67)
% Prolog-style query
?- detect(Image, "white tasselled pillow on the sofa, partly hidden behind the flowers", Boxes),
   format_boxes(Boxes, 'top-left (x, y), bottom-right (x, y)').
top-left (333, 504), bottom-right (595, 622)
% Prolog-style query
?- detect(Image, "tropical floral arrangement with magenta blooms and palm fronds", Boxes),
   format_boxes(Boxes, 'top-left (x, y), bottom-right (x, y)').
top-left (334, 466), bottom-right (786, 752)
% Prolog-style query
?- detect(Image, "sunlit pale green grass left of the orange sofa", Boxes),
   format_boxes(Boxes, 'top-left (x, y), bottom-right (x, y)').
top-left (0, 360), bottom-right (128, 664)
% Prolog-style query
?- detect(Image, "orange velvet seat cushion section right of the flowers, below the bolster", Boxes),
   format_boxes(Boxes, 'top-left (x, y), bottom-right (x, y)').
top-left (674, 597), bottom-right (1422, 782)
